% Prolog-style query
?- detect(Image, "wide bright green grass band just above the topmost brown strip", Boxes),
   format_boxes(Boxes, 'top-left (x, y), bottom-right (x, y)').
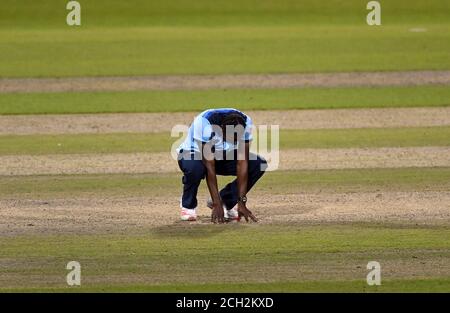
top-left (0, 23), bottom-right (450, 77)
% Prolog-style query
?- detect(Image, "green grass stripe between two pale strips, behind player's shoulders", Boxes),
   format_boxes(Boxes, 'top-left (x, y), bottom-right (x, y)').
top-left (0, 127), bottom-right (450, 155)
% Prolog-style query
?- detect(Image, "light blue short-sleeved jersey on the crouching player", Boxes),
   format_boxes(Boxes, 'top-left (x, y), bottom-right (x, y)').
top-left (177, 108), bottom-right (253, 153)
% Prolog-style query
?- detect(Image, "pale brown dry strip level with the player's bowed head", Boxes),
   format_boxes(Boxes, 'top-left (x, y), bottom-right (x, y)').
top-left (0, 107), bottom-right (450, 135)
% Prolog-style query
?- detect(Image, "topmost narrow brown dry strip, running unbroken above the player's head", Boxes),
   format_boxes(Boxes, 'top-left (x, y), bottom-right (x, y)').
top-left (0, 71), bottom-right (450, 93)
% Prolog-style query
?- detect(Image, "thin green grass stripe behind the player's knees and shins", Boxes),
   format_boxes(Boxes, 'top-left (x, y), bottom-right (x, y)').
top-left (0, 168), bottom-right (450, 198)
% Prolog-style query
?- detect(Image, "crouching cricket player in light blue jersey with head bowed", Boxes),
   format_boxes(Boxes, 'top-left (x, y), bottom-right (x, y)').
top-left (177, 108), bottom-right (267, 223)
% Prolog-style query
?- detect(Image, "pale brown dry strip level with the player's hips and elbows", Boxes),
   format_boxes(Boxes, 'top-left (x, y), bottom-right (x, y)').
top-left (0, 147), bottom-right (450, 176)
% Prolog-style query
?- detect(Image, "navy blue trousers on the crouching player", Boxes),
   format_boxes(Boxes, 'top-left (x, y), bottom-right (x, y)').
top-left (178, 155), bottom-right (267, 209)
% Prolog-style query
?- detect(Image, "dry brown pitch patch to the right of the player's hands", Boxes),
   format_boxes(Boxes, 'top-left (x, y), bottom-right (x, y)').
top-left (258, 191), bottom-right (450, 224)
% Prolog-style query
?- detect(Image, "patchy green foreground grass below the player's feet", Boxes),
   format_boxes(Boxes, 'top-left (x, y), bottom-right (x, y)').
top-left (0, 225), bottom-right (450, 292)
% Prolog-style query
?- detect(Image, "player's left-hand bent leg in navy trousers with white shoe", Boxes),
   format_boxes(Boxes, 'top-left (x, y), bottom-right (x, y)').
top-left (178, 159), bottom-right (206, 221)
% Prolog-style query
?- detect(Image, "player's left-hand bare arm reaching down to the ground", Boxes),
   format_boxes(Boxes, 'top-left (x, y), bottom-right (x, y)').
top-left (201, 143), bottom-right (225, 223)
